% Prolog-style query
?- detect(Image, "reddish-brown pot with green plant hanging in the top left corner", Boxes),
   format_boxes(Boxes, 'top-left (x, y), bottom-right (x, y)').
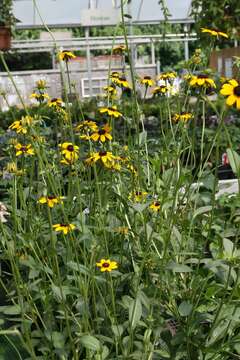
top-left (0, 0), bottom-right (16, 50)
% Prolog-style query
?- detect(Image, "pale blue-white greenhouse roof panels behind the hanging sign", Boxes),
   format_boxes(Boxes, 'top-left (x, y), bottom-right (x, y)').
top-left (14, 0), bottom-right (192, 28)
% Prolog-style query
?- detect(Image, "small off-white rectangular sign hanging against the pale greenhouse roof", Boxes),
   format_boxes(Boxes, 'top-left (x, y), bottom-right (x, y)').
top-left (80, 9), bottom-right (120, 26)
